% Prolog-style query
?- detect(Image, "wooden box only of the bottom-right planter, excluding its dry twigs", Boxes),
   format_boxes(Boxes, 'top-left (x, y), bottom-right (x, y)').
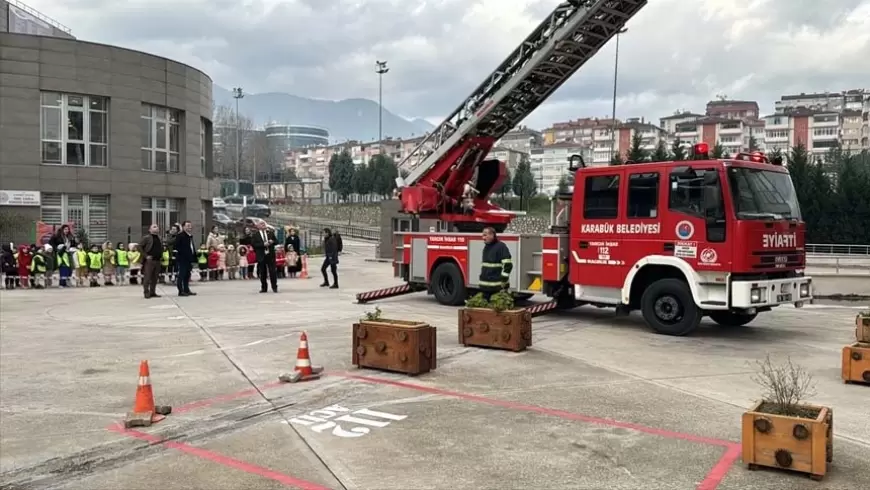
top-left (742, 401), bottom-right (834, 480)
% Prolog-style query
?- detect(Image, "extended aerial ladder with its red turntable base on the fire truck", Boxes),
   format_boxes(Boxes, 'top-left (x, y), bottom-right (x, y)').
top-left (396, 0), bottom-right (647, 231)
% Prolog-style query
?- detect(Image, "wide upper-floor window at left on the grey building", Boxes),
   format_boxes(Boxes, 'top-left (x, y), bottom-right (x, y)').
top-left (40, 92), bottom-right (109, 167)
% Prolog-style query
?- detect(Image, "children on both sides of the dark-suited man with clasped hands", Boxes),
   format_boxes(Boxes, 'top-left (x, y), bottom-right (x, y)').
top-left (196, 244), bottom-right (300, 281)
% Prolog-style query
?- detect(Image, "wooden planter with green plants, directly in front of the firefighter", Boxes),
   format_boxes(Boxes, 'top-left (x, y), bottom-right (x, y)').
top-left (459, 291), bottom-right (532, 352)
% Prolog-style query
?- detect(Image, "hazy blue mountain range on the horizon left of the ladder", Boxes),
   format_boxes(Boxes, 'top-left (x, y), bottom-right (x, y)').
top-left (214, 85), bottom-right (434, 142)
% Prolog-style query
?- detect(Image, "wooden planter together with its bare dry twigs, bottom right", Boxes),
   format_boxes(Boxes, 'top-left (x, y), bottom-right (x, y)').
top-left (742, 356), bottom-right (834, 480)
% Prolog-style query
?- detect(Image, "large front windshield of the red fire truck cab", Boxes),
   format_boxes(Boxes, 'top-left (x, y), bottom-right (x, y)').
top-left (728, 167), bottom-right (801, 220)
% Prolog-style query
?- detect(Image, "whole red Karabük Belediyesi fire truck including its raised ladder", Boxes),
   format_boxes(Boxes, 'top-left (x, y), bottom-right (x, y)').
top-left (357, 0), bottom-right (812, 335)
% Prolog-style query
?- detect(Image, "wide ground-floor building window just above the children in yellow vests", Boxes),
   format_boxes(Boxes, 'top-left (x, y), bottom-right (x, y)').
top-left (40, 192), bottom-right (109, 245)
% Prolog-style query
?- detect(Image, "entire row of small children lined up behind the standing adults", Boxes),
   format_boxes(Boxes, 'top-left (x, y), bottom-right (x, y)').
top-left (0, 237), bottom-right (301, 289)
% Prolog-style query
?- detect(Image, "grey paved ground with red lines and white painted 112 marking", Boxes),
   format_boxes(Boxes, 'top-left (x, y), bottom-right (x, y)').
top-left (0, 245), bottom-right (870, 490)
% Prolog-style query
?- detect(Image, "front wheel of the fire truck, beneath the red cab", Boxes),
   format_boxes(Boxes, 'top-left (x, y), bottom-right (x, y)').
top-left (640, 279), bottom-right (702, 336)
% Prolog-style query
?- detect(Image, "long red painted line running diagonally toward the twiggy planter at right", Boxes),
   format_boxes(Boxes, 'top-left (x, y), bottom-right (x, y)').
top-left (333, 373), bottom-right (734, 447)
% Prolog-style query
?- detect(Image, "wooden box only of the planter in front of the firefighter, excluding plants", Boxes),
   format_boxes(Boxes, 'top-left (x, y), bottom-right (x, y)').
top-left (459, 308), bottom-right (532, 352)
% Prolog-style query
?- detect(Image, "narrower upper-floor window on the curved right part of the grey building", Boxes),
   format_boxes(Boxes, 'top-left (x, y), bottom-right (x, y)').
top-left (142, 104), bottom-right (181, 172)
